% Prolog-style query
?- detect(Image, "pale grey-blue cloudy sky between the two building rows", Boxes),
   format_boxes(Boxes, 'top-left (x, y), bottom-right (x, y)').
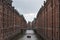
top-left (12, 0), bottom-right (45, 22)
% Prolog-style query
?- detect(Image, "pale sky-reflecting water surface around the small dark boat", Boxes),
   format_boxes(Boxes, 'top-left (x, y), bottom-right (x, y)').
top-left (12, 30), bottom-right (40, 40)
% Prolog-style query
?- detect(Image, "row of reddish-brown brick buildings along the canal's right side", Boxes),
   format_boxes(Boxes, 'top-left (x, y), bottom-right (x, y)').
top-left (35, 0), bottom-right (60, 40)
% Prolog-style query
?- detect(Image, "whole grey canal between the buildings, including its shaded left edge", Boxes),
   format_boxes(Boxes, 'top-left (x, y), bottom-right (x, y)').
top-left (13, 30), bottom-right (41, 40)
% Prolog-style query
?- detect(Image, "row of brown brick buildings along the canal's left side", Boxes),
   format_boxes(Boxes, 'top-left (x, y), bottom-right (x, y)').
top-left (0, 0), bottom-right (26, 40)
